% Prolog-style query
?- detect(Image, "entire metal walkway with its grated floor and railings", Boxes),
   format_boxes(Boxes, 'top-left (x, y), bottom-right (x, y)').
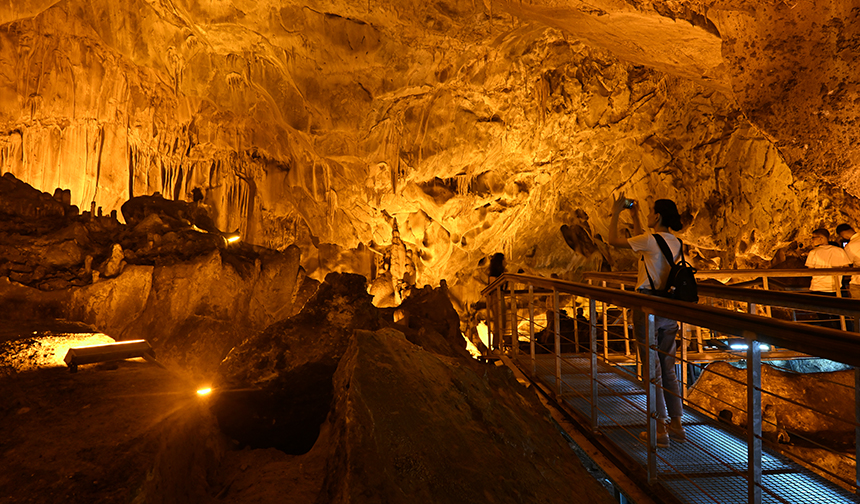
top-left (482, 273), bottom-right (860, 504)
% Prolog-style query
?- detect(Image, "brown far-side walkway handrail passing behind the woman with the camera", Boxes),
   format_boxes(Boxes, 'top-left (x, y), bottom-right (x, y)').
top-left (585, 268), bottom-right (860, 317)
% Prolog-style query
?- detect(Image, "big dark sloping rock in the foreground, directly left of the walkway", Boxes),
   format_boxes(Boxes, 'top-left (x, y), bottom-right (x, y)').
top-left (316, 329), bottom-right (613, 504)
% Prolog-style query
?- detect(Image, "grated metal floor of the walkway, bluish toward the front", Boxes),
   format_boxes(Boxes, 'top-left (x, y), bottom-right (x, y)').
top-left (517, 354), bottom-right (860, 504)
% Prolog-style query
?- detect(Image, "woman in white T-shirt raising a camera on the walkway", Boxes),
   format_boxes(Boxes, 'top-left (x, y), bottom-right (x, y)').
top-left (608, 196), bottom-right (687, 448)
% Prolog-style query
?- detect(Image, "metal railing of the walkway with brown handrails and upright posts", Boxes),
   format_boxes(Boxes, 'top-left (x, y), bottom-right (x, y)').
top-left (483, 270), bottom-right (860, 503)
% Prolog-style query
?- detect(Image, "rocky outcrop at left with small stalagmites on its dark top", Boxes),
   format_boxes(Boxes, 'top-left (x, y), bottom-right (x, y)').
top-left (0, 174), bottom-right (318, 376)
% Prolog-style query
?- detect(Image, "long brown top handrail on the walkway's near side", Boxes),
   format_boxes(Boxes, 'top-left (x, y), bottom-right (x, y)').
top-left (481, 273), bottom-right (860, 366)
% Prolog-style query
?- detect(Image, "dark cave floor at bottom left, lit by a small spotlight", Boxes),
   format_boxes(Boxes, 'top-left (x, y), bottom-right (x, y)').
top-left (0, 350), bottom-right (327, 503)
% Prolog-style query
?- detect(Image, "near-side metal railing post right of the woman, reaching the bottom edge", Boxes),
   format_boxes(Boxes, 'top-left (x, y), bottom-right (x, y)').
top-left (746, 334), bottom-right (761, 504)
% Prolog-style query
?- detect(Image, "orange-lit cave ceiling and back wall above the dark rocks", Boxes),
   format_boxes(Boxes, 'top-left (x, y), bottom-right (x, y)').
top-left (0, 0), bottom-right (860, 292)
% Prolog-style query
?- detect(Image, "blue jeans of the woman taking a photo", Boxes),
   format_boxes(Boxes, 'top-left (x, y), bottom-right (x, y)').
top-left (633, 289), bottom-right (684, 421)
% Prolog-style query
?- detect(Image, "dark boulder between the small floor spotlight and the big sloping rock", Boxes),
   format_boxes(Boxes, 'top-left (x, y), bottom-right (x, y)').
top-left (213, 273), bottom-right (380, 454)
